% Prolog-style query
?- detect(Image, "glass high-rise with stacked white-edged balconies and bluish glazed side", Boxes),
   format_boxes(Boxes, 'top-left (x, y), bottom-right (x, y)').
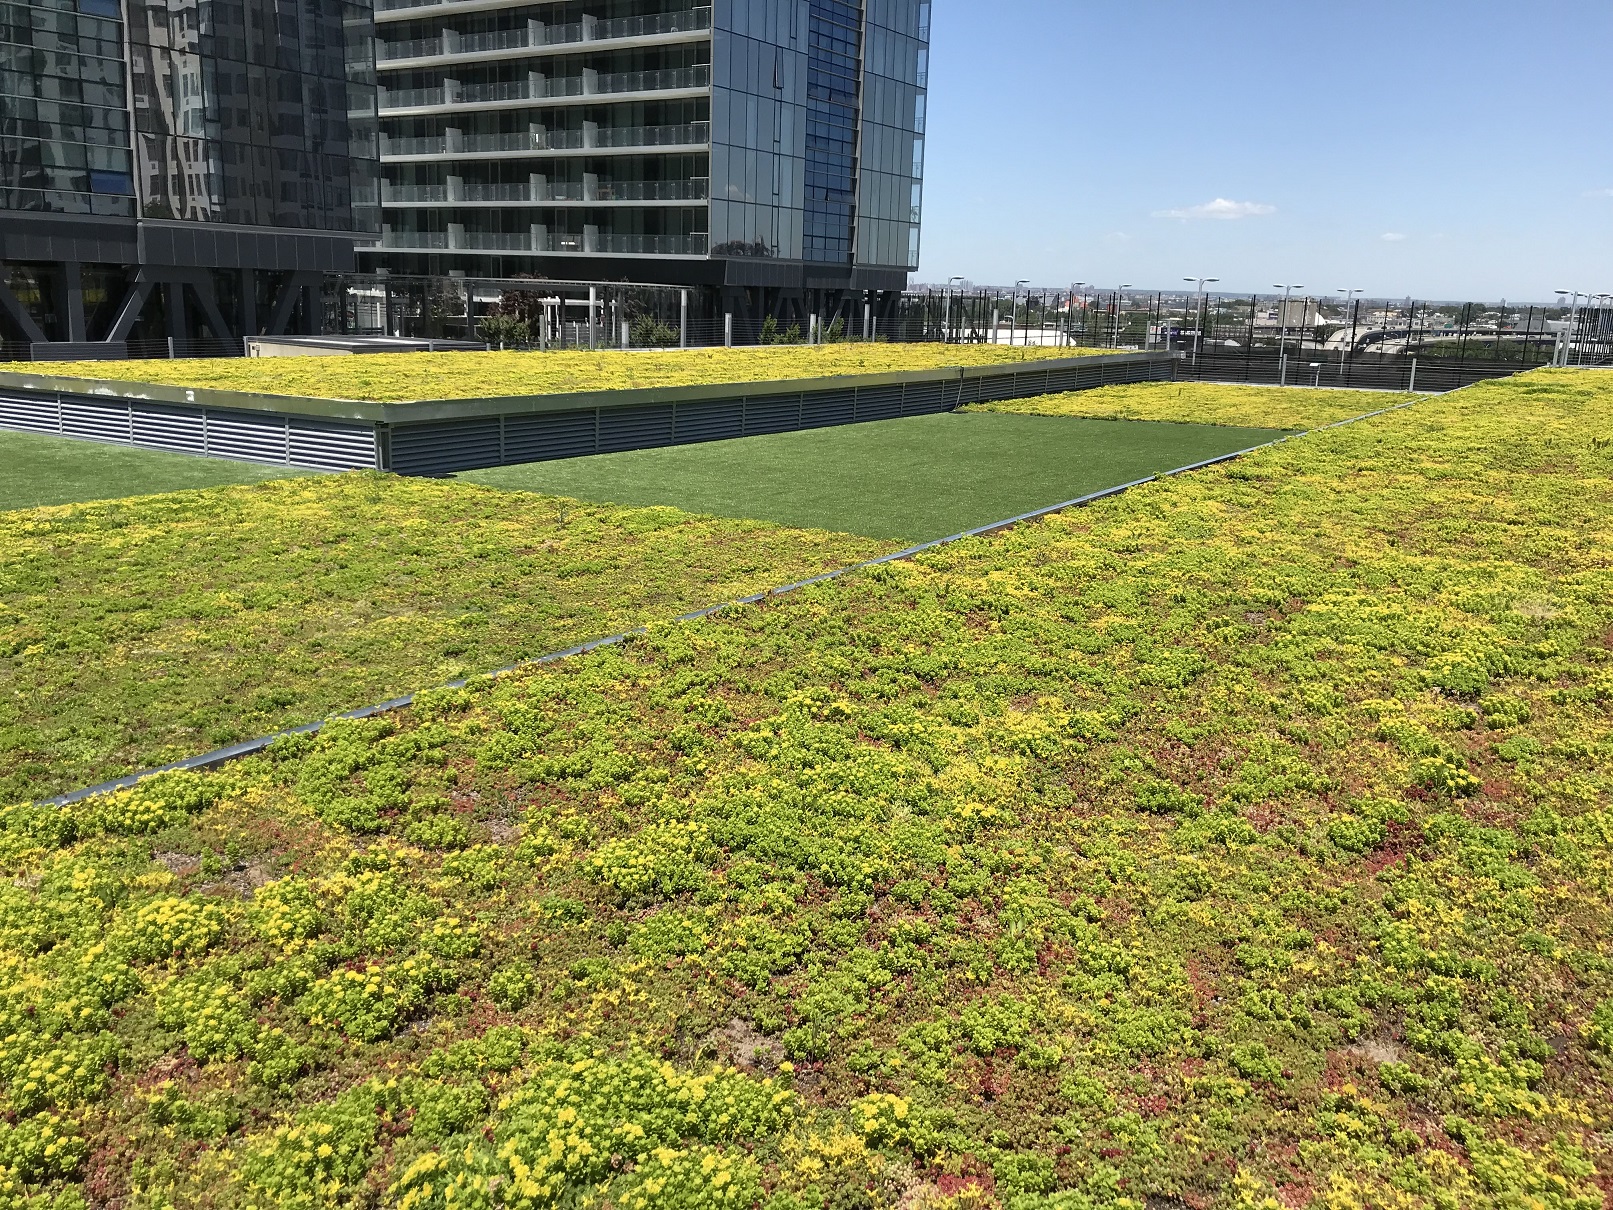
top-left (360, 0), bottom-right (931, 313)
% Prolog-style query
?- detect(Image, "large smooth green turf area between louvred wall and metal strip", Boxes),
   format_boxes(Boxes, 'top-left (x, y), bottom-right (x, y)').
top-left (460, 413), bottom-right (1281, 542)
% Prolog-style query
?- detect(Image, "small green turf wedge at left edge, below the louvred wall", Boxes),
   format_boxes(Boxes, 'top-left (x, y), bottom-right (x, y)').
top-left (0, 431), bottom-right (313, 513)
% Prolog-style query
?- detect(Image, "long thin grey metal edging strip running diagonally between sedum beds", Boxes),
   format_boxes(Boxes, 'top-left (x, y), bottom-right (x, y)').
top-left (35, 400), bottom-right (1419, 807)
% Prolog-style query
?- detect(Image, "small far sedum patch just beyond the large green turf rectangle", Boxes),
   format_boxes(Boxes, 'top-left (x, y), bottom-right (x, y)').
top-left (963, 382), bottom-right (1418, 429)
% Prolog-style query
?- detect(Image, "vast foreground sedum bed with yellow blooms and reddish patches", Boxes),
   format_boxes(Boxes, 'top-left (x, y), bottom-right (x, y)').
top-left (0, 371), bottom-right (1613, 1210)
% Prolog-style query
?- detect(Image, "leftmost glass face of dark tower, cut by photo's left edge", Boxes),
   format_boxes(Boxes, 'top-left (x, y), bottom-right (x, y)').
top-left (0, 0), bottom-right (135, 218)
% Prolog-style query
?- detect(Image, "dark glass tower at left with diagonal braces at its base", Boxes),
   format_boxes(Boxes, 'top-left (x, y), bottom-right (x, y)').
top-left (0, 0), bottom-right (379, 352)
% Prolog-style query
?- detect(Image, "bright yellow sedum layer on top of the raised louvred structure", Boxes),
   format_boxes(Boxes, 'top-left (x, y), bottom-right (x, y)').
top-left (0, 344), bottom-right (1107, 403)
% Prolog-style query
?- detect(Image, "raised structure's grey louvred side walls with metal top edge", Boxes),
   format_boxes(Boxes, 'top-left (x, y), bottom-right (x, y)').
top-left (0, 353), bottom-right (1181, 474)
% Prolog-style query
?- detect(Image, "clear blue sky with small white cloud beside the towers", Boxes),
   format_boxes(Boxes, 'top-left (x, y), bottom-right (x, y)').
top-left (915, 0), bottom-right (1613, 300)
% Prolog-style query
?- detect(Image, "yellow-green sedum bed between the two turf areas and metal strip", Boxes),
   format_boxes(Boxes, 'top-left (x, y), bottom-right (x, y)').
top-left (0, 477), bottom-right (897, 802)
